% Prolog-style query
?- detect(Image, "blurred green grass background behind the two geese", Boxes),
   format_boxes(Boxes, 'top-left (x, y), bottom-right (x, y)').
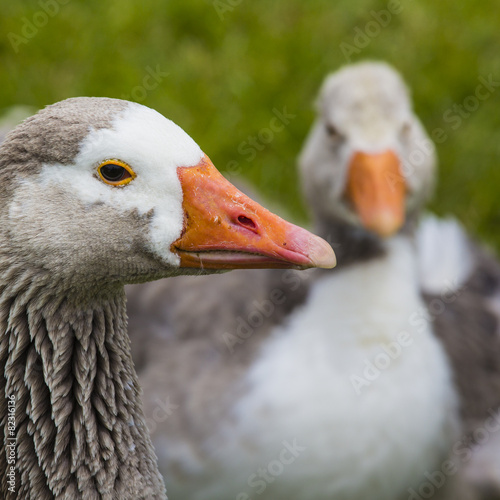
top-left (0, 0), bottom-right (500, 251)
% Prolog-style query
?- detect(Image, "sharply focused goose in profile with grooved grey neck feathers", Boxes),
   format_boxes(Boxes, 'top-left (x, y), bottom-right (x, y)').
top-left (0, 97), bottom-right (335, 500)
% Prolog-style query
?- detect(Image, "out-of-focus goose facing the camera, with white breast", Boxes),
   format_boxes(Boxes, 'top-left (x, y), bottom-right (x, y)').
top-left (128, 62), bottom-right (500, 500)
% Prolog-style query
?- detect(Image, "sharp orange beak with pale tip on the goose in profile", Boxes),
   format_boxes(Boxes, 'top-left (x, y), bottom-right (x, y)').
top-left (171, 156), bottom-right (336, 269)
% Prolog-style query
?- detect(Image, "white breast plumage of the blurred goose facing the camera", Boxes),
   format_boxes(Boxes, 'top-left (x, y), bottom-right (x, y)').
top-left (171, 238), bottom-right (458, 500)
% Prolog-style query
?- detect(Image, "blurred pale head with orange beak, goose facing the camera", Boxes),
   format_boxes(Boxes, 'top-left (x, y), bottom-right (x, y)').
top-left (299, 62), bottom-right (435, 238)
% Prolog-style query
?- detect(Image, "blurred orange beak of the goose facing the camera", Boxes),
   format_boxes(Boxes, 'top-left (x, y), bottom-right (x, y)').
top-left (346, 150), bottom-right (406, 237)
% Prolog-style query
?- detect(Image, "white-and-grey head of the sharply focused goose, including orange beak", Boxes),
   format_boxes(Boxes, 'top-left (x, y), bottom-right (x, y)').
top-left (0, 98), bottom-right (334, 288)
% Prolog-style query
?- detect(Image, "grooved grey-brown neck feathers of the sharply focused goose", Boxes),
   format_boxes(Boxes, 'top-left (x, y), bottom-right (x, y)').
top-left (0, 253), bottom-right (166, 500)
